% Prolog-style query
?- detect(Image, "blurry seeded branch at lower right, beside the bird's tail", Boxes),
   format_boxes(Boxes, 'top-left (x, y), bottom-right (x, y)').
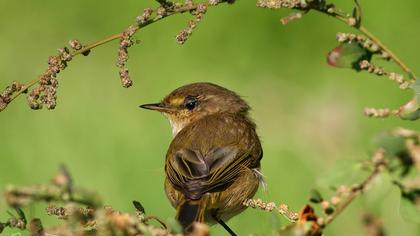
top-left (243, 128), bottom-right (420, 236)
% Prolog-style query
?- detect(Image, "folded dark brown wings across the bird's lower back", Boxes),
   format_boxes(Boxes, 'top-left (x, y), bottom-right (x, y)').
top-left (166, 146), bottom-right (252, 199)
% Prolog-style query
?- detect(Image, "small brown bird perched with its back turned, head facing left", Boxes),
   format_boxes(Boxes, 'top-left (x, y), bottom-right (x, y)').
top-left (140, 83), bottom-right (263, 235)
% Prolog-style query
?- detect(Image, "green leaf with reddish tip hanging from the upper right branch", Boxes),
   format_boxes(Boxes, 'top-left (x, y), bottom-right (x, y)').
top-left (327, 41), bottom-right (372, 71)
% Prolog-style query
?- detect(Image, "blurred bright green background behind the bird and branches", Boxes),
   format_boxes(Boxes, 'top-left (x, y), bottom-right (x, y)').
top-left (0, 0), bottom-right (420, 235)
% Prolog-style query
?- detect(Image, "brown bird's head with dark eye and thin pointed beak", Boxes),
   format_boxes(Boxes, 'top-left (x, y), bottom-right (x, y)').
top-left (140, 83), bottom-right (250, 136)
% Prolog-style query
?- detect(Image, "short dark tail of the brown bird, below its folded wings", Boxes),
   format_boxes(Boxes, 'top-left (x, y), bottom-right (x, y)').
top-left (176, 199), bottom-right (206, 232)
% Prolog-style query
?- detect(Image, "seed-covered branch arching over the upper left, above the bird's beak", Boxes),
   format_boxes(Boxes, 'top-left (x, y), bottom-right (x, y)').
top-left (0, 0), bottom-right (233, 112)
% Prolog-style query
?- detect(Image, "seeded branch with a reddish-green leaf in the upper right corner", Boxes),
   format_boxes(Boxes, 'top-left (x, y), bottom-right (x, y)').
top-left (257, 0), bottom-right (420, 120)
